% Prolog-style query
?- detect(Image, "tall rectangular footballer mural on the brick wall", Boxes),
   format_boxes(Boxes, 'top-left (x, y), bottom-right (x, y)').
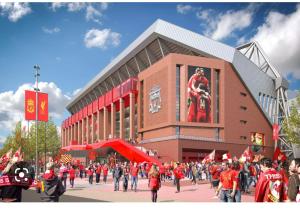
top-left (187, 66), bottom-right (211, 123)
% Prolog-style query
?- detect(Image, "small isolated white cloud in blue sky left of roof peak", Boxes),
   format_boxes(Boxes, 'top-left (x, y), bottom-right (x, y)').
top-left (84, 28), bottom-right (121, 49)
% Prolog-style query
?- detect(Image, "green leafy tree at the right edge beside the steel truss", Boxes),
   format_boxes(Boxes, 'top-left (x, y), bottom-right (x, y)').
top-left (282, 93), bottom-right (300, 145)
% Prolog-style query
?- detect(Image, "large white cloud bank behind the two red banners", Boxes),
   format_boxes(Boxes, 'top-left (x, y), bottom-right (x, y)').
top-left (0, 82), bottom-right (70, 130)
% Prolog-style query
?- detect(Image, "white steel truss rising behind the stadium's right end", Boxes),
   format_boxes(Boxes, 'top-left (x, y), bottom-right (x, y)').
top-left (237, 41), bottom-right (293, 157)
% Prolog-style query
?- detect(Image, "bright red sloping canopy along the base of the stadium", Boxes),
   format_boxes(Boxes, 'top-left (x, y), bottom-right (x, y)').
top-left (62, 139), bottom-right (161, 166)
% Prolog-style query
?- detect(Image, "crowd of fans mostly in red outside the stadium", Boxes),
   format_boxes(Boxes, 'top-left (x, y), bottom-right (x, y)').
top-left (0, 149), bottom-right (300, 202)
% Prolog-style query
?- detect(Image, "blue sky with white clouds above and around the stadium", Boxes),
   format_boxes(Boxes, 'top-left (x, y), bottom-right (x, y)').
top-left (0, 2), bottom-right (300, 147)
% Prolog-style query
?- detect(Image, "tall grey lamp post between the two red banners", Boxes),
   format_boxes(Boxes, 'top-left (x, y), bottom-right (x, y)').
top-left (33, 65), bottom-right (40, 178)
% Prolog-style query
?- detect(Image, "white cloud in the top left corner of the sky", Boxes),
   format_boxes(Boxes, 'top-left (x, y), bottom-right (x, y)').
top-left (0, 2), bottom-right (31, 22)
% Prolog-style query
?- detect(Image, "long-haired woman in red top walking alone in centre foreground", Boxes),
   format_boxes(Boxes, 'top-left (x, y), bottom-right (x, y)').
top-left (148, 164), bottom-right (161, 202)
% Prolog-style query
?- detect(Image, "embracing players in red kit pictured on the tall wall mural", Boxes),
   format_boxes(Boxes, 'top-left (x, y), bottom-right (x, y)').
top-left (187, 68), bottom-right (209, 122)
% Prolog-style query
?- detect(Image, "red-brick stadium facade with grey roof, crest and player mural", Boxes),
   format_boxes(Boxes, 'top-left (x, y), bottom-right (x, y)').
top-left (61, 20), bottom-right (288, 162)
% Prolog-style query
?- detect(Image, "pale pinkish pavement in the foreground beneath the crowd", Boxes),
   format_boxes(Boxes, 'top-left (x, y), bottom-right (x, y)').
top-left (23, 177), bottom-right (254, 202)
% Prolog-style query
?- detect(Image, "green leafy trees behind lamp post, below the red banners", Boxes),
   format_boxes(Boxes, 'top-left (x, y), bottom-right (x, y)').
top-left (0, 118), bottom-right (61, 160)
